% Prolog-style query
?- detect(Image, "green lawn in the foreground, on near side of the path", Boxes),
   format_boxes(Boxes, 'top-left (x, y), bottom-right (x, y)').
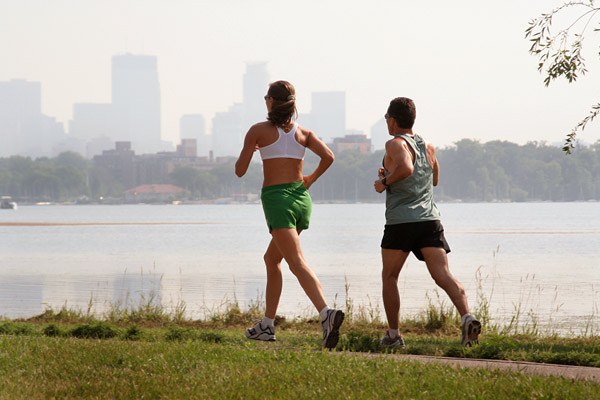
top-left (0, 328), bottom-right (600, 399)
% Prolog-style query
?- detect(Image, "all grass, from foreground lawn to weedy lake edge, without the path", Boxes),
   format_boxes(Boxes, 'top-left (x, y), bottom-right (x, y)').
top-left (0, 302), bottom-right (600, 399)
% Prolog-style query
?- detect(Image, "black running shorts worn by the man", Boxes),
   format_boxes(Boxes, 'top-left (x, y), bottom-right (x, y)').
top-left (381, 220), bottom-right (450, 261)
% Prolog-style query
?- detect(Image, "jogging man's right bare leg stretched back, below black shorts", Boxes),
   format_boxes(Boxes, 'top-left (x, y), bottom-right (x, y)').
top-left (421, 247), bottom-right (469, 316)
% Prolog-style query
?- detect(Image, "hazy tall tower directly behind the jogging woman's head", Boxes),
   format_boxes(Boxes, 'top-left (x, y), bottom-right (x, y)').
top-left (242, 62), bottom-right (269, 129)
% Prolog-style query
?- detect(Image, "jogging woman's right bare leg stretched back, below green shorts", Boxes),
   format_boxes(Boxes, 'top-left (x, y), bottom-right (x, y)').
top-left (271, 228), bottom-right (327, 311)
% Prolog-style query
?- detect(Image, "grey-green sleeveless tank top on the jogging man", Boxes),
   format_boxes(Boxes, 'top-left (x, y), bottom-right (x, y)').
top-left (385, 134), bottom-right (440, 225)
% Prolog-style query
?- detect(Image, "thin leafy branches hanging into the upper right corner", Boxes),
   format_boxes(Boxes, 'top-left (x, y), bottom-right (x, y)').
top-left (525, 0), bottom-right (600, 154)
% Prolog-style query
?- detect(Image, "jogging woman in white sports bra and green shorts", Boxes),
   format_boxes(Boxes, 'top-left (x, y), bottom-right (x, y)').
top-left (235, 81), bottom-right (344, 349)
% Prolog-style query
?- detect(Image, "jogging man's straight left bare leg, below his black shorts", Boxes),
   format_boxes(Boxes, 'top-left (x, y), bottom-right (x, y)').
top-left (381, 249), bottom-right (410, 329)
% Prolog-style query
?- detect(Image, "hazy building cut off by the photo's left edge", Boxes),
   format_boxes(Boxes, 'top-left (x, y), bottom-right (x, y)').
top-left (0, 79), bottom-right (64, 157)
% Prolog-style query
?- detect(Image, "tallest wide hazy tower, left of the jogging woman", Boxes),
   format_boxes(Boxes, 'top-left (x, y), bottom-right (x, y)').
top-left (112, 54), bottom-right (163, 153)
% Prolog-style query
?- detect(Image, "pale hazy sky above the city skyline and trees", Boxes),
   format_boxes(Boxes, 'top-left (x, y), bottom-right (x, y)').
top-left (0, 0), bottom-right (600, 146)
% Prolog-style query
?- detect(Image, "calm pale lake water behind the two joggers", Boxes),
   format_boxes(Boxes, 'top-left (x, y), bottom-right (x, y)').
top-left (0, 203), bottom-right (600, 333)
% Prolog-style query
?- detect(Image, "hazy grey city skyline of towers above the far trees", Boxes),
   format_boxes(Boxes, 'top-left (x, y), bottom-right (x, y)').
top-left (0, 58), bottom-right (370, 159)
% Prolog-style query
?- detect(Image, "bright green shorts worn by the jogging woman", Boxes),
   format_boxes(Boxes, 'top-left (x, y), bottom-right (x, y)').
top-left (260, 181), bottom-right (312, 232)
